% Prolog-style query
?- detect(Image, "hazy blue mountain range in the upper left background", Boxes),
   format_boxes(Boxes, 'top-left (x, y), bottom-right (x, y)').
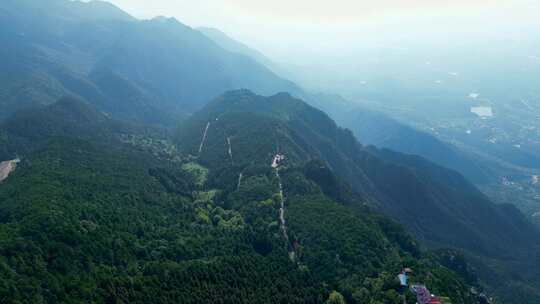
top-left (0, 0), bottom-right (299, 125)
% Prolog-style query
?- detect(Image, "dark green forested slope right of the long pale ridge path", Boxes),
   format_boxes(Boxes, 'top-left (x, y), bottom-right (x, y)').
top-left (284, 166), bottom-right (475, 303)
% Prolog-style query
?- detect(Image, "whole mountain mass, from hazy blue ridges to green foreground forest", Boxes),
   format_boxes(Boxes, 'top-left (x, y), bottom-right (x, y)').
top-left (0, 0), bottom-right (539, 303)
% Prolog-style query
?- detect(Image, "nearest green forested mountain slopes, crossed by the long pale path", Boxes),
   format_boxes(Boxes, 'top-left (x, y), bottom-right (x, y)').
top-left (0, 93), bottom-right (482, 303)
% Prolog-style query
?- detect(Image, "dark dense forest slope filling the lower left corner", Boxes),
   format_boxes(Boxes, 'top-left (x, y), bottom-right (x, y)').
top-left (0, 139), bottom-right (325, 303)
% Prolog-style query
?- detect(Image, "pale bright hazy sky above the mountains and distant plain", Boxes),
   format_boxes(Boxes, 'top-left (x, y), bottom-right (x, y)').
top-left (99, 0), bottom-right (540, 63)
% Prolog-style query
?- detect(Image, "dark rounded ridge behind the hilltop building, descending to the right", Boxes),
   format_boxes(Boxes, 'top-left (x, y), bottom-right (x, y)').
top-left (179, 90), bottom-right (534, 252)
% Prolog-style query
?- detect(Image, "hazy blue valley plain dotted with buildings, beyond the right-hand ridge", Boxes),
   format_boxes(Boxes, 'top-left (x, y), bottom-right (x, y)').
top-left (370, 95), bottom-right (540, 228)
